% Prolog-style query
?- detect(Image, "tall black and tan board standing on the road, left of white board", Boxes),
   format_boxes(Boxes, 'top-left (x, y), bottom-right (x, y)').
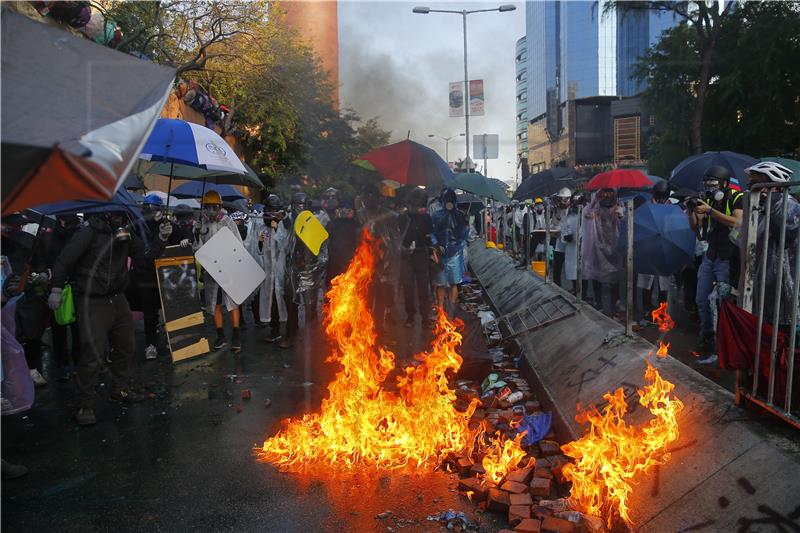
top-left (155, 246), bottom-right (209, 362)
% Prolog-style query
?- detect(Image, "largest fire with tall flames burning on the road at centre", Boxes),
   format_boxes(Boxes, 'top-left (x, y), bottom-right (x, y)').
top-left (256, 232), bottom-right (477, 470)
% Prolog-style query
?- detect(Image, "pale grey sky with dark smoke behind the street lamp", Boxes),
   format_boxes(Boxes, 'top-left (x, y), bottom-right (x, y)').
top-left (339, 0), bottom-right (525, 187)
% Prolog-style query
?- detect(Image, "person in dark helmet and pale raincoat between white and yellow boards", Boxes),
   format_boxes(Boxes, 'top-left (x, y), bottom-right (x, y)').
top-left (258, 194), bottom-right (289, 348)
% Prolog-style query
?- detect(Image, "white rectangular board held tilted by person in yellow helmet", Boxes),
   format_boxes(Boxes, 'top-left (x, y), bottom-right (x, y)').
top-left (195, 228), bottom-right (266, 305)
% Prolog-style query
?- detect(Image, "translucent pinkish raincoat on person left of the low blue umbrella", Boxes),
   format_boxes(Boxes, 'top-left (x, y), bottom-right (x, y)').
top-left (583, 196), bottom-right (623, 283)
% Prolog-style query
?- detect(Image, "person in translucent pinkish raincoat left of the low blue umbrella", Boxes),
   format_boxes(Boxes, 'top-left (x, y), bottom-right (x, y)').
top-left (583, 189), bottom-right (624, 316)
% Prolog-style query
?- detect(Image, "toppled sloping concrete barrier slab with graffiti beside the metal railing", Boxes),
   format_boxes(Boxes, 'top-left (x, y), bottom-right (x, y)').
top-left (469, 241), bottom-right (800, 533)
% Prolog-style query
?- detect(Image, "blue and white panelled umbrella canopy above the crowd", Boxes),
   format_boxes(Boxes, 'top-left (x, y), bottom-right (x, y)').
top-left (139, 118), bottom-right (247, 176)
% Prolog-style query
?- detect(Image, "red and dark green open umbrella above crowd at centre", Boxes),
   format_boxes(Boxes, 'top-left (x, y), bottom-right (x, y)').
top-left (353, 140), bottom-right (453, 189)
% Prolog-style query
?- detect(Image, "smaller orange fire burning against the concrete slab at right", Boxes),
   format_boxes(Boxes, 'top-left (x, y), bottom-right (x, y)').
top-left (561, 362), bottom-right (683, 528)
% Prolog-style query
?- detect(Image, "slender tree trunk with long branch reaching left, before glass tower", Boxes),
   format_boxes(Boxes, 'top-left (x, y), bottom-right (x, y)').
top-left (604, 0), bottom-right (735, 154)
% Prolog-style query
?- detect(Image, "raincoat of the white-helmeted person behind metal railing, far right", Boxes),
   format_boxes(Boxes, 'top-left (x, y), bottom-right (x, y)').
top-left (753, 192), bottom-right (800, 325)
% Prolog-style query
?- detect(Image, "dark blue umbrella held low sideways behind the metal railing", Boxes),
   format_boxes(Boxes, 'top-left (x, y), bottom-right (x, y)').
top-left (618, 203), bottom-right (695, 276)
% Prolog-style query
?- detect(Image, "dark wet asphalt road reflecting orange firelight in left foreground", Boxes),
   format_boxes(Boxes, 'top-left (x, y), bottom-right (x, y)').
top-left (1, 312), bottom-right (504, 532)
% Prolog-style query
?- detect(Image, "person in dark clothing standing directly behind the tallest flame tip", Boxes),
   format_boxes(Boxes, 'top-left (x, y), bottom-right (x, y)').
top-left (358, 184), bottom-right (398, 327)
